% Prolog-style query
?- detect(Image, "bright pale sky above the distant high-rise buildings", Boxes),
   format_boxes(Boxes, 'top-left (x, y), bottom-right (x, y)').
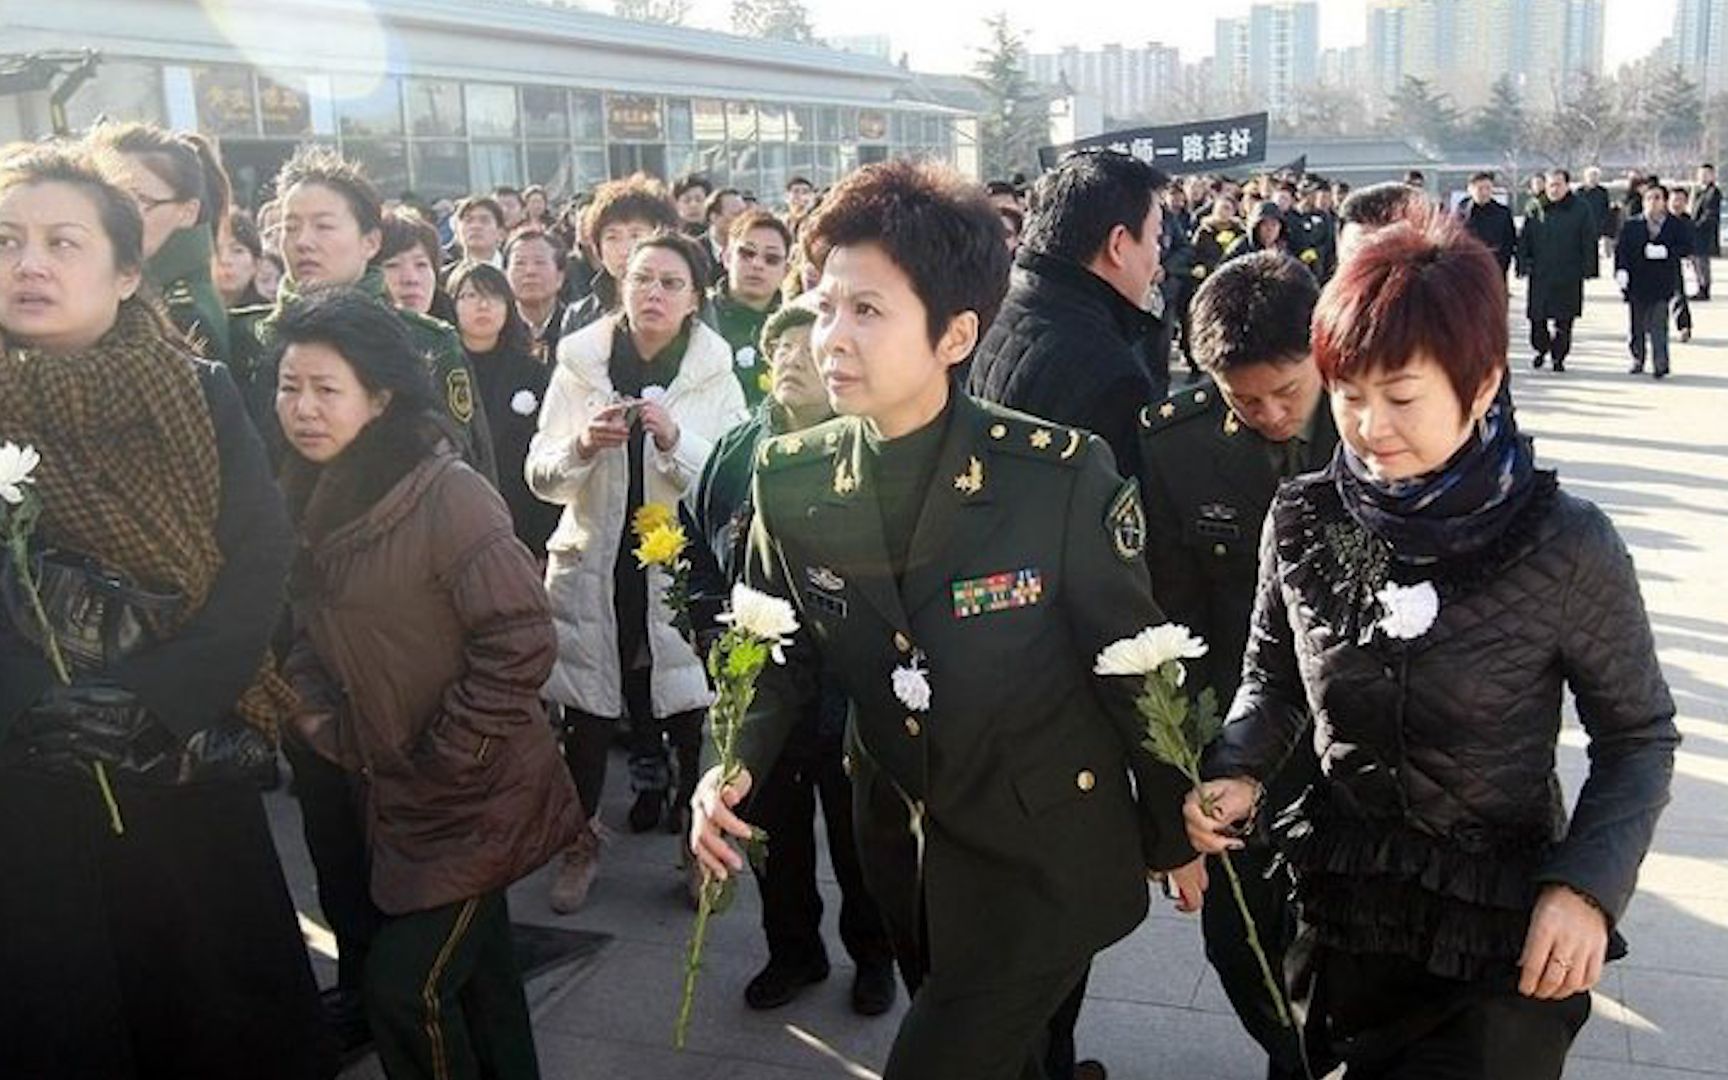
top-left (684, 0), bottom-right (1678, 73)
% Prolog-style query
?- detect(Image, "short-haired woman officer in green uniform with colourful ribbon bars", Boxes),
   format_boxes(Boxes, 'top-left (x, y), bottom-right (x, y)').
top-left (691, 162), bottom-right (1203, 1080)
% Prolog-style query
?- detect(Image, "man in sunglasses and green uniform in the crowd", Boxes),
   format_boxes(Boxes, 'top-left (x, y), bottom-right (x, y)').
top-left (707, 211), bottom-right (791, 408)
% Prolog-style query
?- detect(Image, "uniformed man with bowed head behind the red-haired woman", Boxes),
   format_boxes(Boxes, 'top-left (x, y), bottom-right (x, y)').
top-left (1140, 252), bottom-right (1337, 1080)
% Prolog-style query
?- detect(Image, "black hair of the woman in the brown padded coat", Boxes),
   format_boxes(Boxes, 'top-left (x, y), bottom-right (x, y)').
top-left (273, 285), bottom-right (439, 413)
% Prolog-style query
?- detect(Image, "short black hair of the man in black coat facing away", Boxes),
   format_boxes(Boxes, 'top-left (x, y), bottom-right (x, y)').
top-left (1023, 150), bottom-right (1170, 264)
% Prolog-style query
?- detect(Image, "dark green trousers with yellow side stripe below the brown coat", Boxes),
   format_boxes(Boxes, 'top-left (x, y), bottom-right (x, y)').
top-left (366, 890), bottom-right (539, 1080)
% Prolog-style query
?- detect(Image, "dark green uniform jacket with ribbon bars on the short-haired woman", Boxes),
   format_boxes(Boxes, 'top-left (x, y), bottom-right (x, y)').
top-left (740, 396), bottom-right (1194, 988)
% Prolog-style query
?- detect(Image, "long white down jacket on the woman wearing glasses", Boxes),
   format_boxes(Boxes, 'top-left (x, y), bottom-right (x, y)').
top-left (525, 316), bottom-right (748, 719)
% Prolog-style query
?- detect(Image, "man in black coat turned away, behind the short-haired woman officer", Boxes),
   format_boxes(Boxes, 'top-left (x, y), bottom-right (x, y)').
top-left (971, 152), bottom-right (1168, 477)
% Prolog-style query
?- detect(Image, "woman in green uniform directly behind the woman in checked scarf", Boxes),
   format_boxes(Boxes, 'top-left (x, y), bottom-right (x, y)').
top-left (88, 124), bottom-right (230, 363)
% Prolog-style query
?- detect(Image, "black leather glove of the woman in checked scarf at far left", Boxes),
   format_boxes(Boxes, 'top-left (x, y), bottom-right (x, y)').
top-left (12, 683), bottom-right (176, 776)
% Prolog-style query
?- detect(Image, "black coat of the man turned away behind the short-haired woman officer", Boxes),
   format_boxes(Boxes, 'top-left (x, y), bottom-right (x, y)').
top-left (969, 251), bottom-right (1154, 477)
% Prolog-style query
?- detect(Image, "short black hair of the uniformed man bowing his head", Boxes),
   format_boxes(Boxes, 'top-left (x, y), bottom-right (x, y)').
top-left (1189, 251), bottom-right (1320, 375)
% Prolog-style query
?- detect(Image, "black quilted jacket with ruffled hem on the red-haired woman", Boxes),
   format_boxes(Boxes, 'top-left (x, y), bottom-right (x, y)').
top-left (1206, 473), bottom-right (1680, 980)
